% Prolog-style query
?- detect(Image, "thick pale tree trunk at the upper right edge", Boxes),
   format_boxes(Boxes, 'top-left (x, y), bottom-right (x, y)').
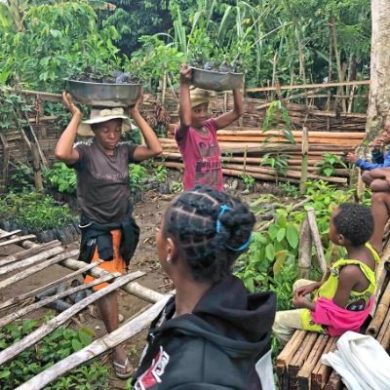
top-left (365, 0), bottom-right (390, 143)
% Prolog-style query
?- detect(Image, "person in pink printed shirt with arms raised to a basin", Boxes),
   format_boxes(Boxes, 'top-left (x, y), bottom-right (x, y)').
top-left (175, 65), bottom-right (243, 191)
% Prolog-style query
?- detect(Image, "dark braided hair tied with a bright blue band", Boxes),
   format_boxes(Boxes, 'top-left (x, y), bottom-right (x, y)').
top-left (162, 186), bottom-right (255, 282)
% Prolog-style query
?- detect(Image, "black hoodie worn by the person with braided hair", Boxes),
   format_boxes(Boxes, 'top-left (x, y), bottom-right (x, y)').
top-left (133, 276), bottom-right (276, 390)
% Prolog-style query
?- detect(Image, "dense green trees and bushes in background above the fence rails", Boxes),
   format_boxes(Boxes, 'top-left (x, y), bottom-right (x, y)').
top-left (0, 0), bottom-right (371, 90)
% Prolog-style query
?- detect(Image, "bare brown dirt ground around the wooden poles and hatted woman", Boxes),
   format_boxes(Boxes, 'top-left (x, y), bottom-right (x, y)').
top-left (0, 187), bottom-right (269, 389)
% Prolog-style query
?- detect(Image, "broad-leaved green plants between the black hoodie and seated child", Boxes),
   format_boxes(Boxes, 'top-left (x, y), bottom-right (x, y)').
top-left (237, 181), bottom-right (369, 310)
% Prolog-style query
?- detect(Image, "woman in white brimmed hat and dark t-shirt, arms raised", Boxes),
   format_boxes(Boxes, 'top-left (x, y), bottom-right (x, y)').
top-left (55, 92), bottom-right (162, 378)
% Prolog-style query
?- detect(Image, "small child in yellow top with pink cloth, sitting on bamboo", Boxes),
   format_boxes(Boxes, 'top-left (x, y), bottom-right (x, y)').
top-left (273, 203), bottom-right (380, 344)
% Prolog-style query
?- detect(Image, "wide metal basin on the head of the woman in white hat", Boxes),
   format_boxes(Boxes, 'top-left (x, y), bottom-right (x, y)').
top-left (65, 79), bottom-right (142, 107)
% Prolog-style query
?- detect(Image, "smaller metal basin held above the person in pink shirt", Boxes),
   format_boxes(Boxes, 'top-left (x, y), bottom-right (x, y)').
top-left (191, 68), bottom-right (244, 91)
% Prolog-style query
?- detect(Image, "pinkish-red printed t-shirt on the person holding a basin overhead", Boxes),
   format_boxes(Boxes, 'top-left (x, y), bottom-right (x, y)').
top-left (175, 119), bottom-right (223, 191)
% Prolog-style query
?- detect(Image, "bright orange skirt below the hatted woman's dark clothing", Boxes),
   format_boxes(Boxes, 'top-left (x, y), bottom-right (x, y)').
top-left (84, 229), bottom-right (126, 291)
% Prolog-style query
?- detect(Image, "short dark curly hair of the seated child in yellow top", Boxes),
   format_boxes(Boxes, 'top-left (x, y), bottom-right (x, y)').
top-left (333, 203), bottom-right (374, 247)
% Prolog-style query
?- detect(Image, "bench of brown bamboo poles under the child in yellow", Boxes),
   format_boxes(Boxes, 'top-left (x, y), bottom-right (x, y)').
top-left (276, 272), bottom-right (390, 390)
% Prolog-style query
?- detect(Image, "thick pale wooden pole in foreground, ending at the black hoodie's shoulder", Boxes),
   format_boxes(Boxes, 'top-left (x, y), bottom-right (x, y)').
top-left (17, 295), bottom-right (170, 390)
